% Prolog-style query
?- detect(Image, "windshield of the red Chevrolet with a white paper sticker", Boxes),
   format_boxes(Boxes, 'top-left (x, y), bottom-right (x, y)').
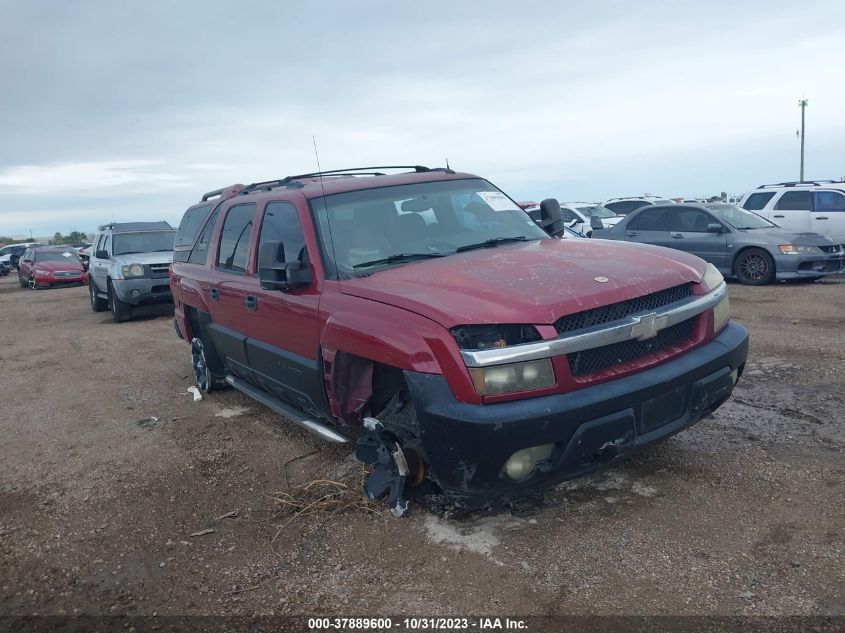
top-left (311, 179), bottom-right (548, 277)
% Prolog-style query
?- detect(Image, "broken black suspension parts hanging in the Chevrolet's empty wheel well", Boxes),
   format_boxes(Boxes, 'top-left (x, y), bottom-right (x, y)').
top-left (355, 418), bottom-right (408, 517)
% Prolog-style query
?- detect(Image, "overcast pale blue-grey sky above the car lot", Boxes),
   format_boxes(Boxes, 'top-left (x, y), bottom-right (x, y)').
top-left (0, 0), bottom-right (845, 236)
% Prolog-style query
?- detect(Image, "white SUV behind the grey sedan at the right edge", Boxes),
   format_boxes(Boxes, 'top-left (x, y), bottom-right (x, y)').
top-left (741, 180), bottom-right (845, 245)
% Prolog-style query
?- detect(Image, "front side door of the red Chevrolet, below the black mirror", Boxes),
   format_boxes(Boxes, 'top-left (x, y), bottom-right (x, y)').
top-left (247, 201), bottom-right (323, 413)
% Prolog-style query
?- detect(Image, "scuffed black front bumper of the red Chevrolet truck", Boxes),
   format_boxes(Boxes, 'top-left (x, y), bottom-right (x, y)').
top-left (405, 323), bottom-right (748, 507)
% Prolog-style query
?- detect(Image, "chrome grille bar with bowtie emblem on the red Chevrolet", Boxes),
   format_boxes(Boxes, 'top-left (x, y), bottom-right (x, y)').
top-left (461, 281), bottom-right (728, 367)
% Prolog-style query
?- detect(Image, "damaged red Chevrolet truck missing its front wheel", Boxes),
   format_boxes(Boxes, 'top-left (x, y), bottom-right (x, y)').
top-left (170, 166), bottom-right (748, 515)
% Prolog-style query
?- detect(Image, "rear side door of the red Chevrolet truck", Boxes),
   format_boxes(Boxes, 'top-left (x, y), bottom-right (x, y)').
top-left (209, 202), bottom-right (256, 381)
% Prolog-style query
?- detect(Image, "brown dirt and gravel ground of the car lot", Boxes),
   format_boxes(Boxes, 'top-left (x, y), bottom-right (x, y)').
top-left (0, 275), bottom-right (845, 616)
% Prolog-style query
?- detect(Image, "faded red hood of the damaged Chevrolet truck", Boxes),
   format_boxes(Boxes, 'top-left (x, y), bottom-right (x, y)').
top-left (340, 239), bottom-right (705, 328)
